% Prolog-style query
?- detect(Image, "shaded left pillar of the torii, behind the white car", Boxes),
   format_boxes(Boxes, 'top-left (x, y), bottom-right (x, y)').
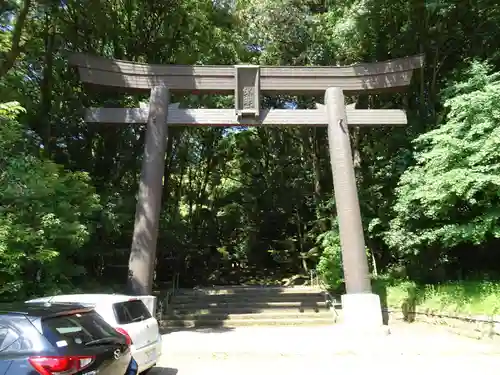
top-left (128, 86), bottom-right (170, 295)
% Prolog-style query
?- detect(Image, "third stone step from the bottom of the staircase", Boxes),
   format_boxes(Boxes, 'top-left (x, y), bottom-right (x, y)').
top-left (170, 303), bottom-right (329, 314)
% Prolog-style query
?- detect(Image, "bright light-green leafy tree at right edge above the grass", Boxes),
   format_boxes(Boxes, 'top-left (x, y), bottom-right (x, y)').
top-left (387, 62), bottom-right (500, 282)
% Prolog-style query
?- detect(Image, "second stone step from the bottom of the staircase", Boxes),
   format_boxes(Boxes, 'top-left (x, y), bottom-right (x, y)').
top-left (167, 310), bottom-right (333, 320)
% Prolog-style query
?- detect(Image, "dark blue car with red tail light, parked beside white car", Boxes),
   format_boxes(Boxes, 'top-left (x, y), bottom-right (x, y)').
top-left (0, 303), bottom-right (134, 375)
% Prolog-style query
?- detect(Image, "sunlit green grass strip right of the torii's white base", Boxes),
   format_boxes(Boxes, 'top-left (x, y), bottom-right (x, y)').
top-left (373, 279), bottom-right (500, 315)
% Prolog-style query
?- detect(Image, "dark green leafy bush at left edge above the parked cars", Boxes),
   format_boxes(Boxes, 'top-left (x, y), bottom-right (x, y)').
top-left (0, 102), bottom-right (100, 296)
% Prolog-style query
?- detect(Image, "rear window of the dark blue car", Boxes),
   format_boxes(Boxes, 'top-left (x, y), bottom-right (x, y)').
top-left (42, 311), bottom-right (122, 348)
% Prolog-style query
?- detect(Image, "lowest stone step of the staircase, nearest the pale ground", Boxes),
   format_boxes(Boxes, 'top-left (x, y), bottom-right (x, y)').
top-left (160, 317), bottom-right (335, 328)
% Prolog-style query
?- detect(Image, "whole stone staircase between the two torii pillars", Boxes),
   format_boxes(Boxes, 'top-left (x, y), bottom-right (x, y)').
top-left (162, 286), bottom-right (335, 328)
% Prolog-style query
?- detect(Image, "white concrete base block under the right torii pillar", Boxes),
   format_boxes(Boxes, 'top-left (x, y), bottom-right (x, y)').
top-left (341, 293), bottom-right (388, 333)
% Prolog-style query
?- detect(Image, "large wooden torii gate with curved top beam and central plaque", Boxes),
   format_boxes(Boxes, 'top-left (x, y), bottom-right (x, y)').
top-left (69, 54), bottom-right (424, 326)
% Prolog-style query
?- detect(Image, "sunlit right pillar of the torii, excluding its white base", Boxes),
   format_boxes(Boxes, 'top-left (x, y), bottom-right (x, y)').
top-left (325, 87), bottom-right (371, 294)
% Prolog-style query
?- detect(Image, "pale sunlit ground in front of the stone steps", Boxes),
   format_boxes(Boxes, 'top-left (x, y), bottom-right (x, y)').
top-left (150, 324), bottom-right (500, 375)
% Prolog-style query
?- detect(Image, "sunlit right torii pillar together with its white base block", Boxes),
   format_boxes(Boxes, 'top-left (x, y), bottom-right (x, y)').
top-left (325, 87), bottom-right (383, 328)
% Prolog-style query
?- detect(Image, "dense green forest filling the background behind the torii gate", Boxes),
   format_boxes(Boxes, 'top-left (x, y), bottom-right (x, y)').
top-left (0, 0), bottom-right (500, 299)
